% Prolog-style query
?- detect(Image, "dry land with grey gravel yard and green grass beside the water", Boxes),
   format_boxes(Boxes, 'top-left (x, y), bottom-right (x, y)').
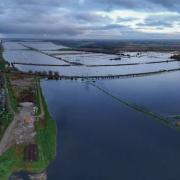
top-left (0, 75), bottom-right (56, 180)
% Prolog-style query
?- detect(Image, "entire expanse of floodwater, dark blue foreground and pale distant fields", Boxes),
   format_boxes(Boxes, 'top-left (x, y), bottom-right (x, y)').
top-left (5, 43), bottom-right (180, 180)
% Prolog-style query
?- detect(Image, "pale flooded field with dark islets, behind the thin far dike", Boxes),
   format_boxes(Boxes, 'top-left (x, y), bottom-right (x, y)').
top-left (56, 52), bottom-right (171, 65)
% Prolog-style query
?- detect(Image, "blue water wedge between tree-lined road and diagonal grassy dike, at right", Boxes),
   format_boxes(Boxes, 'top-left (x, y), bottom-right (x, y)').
top-left (97, 72), bottom-right (180, 116)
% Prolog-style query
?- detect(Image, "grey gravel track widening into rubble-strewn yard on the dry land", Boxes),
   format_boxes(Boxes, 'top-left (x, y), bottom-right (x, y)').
top-left (0, 102), bottom-right (35, 156)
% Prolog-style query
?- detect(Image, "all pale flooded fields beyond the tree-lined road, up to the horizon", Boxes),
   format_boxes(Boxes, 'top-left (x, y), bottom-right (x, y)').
top-left (4, 42), bottom-right (180, 77)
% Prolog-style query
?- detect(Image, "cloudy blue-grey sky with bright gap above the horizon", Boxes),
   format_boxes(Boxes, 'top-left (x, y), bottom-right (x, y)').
top-left (0, 0), bottom-right (180, 39)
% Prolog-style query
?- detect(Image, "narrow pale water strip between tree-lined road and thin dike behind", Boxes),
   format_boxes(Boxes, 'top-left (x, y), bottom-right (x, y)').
top-left (16, 62), bottom-right (180, 77)
